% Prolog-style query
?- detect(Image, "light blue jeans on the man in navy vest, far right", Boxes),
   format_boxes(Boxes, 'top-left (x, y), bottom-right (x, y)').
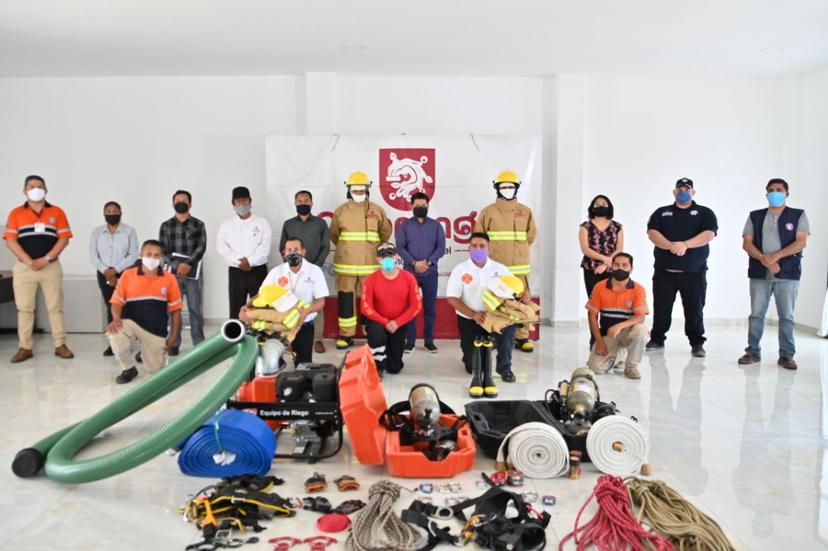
top-left (745, 279), bottom-right (799, 358)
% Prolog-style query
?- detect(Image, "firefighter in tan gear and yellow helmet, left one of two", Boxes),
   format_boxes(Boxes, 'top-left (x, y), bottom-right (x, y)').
top-left (331, 172), bottom-right (392, 350)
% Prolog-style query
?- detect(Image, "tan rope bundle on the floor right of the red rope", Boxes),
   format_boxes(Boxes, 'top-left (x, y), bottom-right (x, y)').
top-left (625, 478), bottom-right (735, 551)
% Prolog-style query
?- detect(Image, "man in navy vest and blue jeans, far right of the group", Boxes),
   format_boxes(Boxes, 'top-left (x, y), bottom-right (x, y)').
top-left (739, 178), bottom-right (811, 369)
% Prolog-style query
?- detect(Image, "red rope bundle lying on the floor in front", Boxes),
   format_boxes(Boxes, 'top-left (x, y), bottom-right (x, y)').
top-left (558, 475), bottom-right (675, 551)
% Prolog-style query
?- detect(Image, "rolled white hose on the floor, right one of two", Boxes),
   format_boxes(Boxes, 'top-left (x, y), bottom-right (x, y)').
top-left (587, 415), bottom-right (650, 476)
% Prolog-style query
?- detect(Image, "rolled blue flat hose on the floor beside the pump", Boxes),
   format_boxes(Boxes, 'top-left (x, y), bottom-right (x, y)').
top-left (178, 409), bottom-right (276, 478)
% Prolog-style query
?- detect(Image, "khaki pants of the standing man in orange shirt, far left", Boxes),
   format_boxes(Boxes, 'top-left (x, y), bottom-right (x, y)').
top-left (12, 261), bottom-right (66, 350)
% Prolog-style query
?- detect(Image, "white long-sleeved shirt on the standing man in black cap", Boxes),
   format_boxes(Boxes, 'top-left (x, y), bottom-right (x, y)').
top-left (216, 214), bottom-right (271, 268)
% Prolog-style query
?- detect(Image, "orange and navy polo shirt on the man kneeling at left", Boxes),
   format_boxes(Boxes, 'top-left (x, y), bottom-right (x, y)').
top-left (109, 264), bottom-right (184, 337)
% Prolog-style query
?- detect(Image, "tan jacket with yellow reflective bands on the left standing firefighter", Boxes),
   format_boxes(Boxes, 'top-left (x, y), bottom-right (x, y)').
top-left (331, 199), bottom-right (391, 276)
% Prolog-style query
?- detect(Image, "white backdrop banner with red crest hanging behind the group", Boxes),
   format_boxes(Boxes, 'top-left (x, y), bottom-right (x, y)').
top-left (265, 135), bottom-right (544, 296)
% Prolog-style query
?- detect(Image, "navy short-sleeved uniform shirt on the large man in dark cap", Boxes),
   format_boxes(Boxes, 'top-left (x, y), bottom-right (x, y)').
top-left (647, 201), bottom-right (719, 273)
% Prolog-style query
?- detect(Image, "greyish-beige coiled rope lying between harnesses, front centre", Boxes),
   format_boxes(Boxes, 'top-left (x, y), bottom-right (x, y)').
top-left (345, 480), bottom-right (421, 551)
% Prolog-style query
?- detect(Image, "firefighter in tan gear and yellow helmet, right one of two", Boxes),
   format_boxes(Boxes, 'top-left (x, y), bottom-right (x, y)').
top-left (474, 170), bottom-right (538, 352)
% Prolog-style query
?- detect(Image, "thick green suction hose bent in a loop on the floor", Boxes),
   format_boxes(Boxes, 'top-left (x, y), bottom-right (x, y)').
top-left (12, 320), bottom-right (258, 484)
